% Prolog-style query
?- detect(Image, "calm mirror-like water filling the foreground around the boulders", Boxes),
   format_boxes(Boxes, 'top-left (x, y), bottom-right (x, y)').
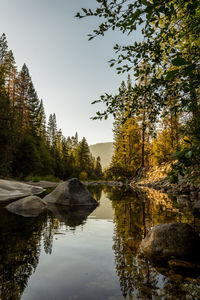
top-left (0, 186), bottom-right (200, 300)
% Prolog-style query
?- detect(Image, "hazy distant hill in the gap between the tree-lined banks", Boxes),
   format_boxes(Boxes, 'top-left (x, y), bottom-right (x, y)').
top-left (90, 142), bottom-right (113, 169)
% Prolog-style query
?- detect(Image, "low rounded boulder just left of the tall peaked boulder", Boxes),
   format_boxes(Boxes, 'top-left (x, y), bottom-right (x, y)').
top-left (6, 196), bottom-right (47, 217)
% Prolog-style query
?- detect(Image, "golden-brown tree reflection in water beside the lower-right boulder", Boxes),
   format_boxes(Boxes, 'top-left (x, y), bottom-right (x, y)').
top-left (111, 189), bottom-right (200, 300)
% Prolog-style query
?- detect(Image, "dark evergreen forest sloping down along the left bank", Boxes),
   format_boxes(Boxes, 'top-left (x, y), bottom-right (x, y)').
top-left (0, 34), bottom-right (102, 179)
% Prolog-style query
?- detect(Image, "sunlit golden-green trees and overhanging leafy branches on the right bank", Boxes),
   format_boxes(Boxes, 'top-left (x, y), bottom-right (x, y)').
top-left (76, 0), bottom-right (200, 183)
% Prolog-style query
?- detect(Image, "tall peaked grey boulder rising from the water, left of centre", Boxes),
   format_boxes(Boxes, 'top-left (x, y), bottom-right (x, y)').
top-left (44, 178), bottom-right (98, 206)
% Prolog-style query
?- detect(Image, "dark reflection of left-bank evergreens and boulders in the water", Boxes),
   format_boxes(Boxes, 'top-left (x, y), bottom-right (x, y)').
top-left (0, 200), bottom-right (95, 300)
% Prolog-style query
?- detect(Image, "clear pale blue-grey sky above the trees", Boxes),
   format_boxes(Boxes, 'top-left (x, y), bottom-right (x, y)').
top-left (0, 0), bottom-right (141, 145)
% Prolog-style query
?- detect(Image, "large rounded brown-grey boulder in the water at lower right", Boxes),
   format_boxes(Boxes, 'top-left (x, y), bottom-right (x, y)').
top-left (141, 223), bottom-right (199, 261)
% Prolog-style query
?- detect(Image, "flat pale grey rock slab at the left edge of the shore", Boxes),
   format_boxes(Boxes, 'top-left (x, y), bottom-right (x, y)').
top-left (0, 179), bottom-right (44, 201)
